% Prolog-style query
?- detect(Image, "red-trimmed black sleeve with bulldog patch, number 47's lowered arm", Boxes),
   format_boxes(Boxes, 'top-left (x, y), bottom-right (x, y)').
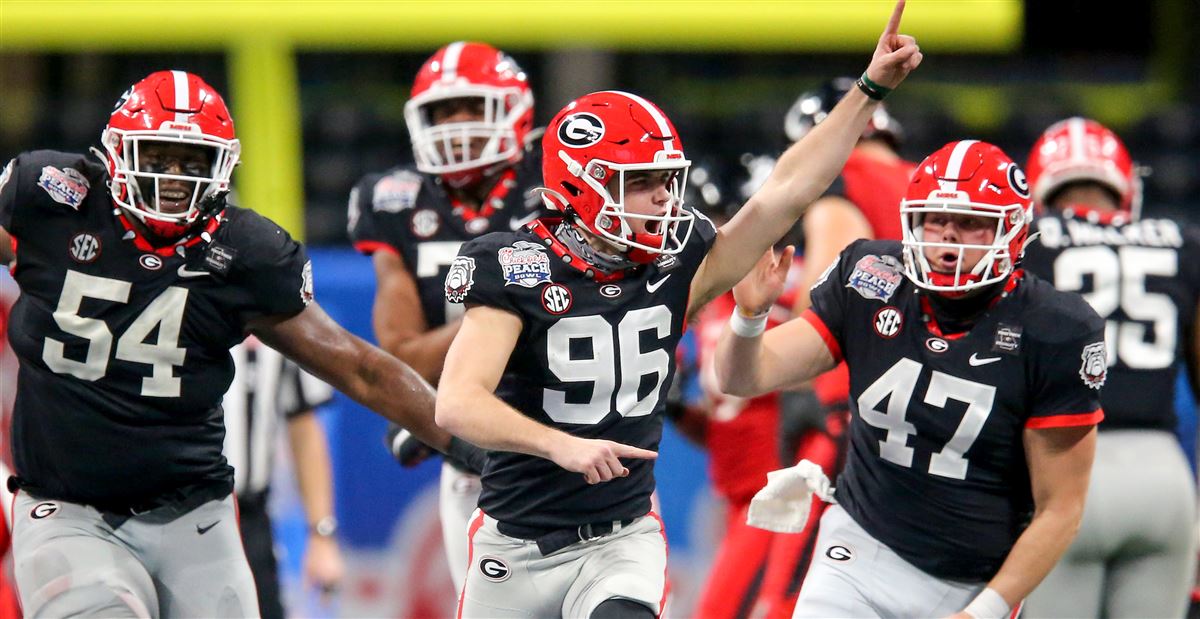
top-left (1026, 301), bottom-right (1108, 427)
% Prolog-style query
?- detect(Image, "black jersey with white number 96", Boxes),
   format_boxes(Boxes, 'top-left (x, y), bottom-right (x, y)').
top-left (445, 216), bottom-right (716, 529)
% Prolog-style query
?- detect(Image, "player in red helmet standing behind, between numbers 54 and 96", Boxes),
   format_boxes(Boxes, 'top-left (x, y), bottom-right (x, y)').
top-left (349, 41), bottom-right (541, 591)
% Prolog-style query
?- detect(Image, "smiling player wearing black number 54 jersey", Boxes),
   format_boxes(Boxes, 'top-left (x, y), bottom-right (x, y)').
top-left (0, 71), bottom-right (475, 617)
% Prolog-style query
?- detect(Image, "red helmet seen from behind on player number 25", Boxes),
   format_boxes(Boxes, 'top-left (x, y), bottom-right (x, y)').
top-left (1026, 116), bottom-right (1141, 220)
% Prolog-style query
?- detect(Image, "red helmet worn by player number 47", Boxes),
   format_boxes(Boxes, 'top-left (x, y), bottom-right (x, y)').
top-left (900, 140), bottom-right (1033, 296)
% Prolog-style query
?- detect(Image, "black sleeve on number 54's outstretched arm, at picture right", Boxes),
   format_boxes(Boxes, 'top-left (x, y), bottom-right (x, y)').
top-left (232, 211), bottom-right (312, 317)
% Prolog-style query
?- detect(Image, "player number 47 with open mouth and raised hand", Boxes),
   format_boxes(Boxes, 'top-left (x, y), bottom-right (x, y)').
top-left (716, 140), bottom-right (1105, 618)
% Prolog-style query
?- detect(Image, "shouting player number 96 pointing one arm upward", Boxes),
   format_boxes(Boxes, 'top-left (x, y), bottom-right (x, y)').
top-left (437, 1), bottom-right (922, 618)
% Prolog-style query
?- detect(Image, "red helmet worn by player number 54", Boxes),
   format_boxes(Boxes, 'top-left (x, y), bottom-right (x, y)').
top-left (101, 71), bottom-right (241, 239)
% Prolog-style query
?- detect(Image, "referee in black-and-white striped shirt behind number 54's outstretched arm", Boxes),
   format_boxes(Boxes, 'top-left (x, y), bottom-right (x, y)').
top-left (222, 336), bottom-right (344, 619)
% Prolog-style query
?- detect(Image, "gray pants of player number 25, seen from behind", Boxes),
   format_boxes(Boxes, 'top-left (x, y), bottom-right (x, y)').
top-left (1025, 431), bottom-right (1196, 619)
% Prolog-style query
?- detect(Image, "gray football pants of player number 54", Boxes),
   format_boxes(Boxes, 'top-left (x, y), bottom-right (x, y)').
top-left (12, 492), bottom-right (258, 619)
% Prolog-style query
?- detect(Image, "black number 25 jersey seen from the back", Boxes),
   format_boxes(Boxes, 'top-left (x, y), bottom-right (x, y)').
top-left (1022, 212), bottom-right (1200, 432)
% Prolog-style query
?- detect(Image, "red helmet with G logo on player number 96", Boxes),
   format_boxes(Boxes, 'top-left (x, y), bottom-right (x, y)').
top-left (541, 90), bottom-right (695, 263)
